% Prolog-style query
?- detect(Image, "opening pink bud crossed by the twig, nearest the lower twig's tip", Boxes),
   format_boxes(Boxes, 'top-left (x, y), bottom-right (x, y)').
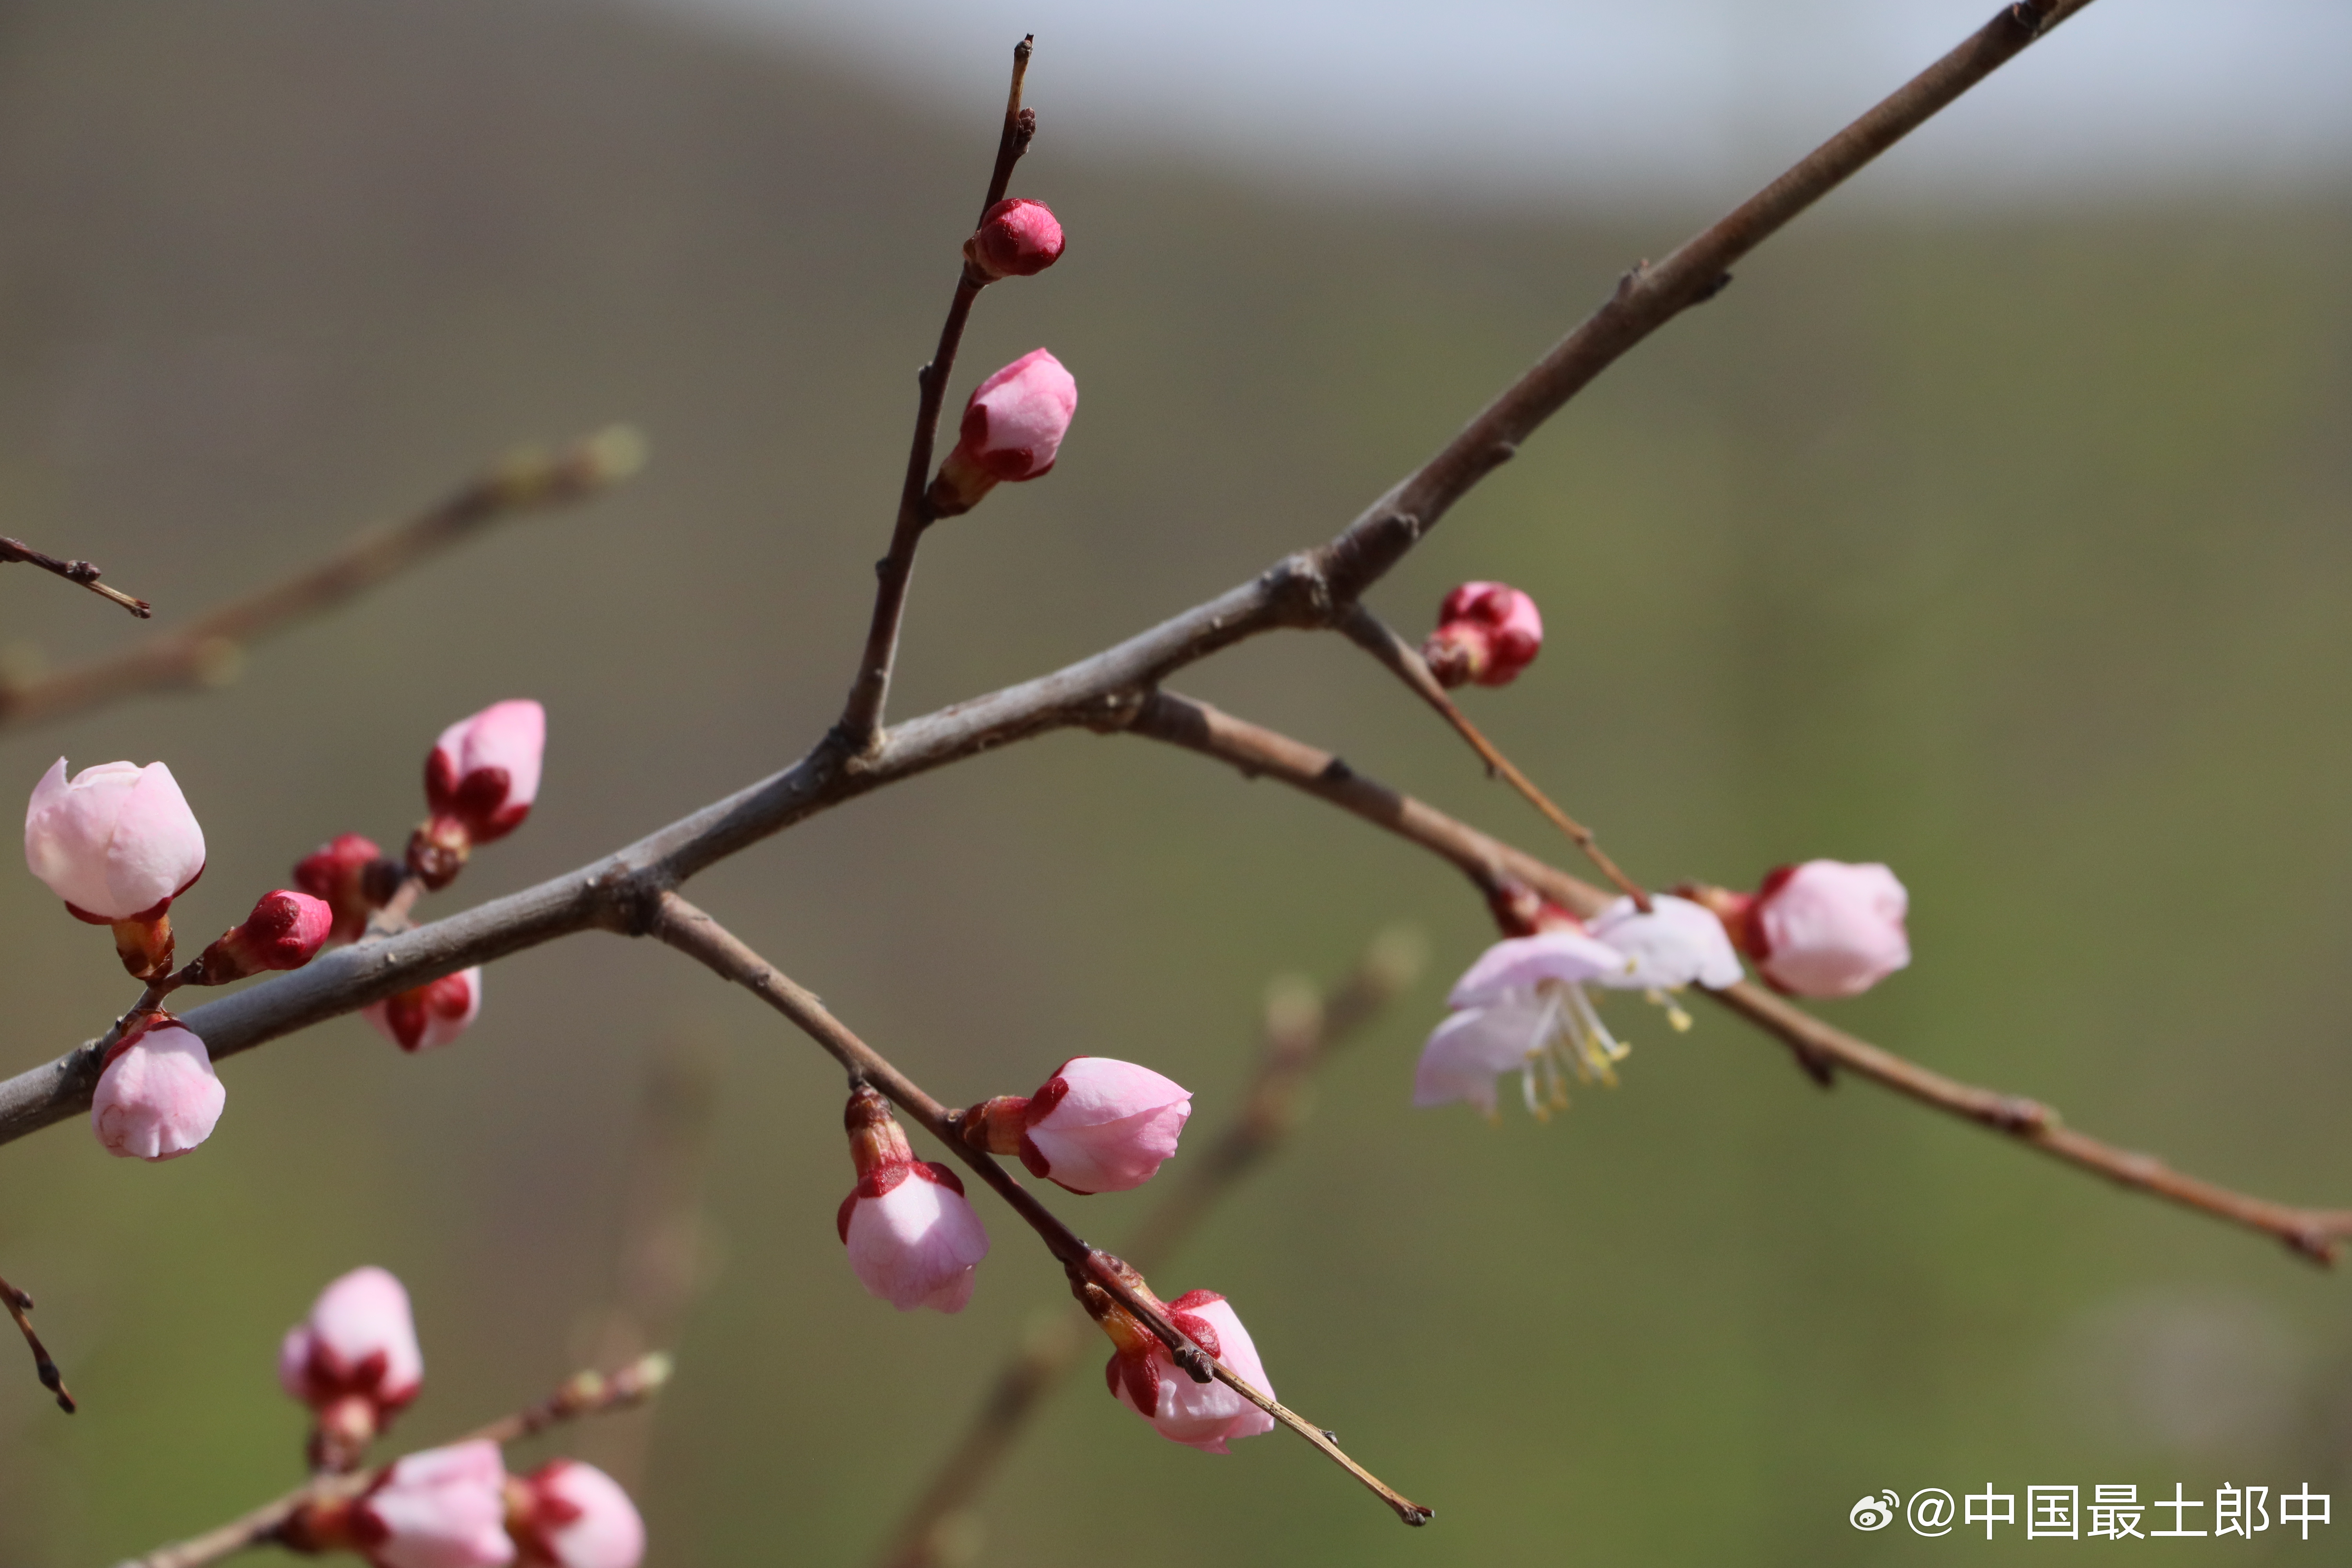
top-left (1075, 1255), bottom-right (1275, 1453)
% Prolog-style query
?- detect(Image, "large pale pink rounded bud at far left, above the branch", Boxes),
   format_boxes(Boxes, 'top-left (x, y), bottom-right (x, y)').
top-left (24, 757), bottom-right (205, 926)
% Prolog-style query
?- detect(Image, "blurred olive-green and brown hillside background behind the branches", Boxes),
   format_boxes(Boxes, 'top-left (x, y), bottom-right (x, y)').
top-left (0, 0), bottom-right (2352, 1568)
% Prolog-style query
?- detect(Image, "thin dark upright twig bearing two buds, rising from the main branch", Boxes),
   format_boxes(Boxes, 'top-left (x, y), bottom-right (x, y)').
top-left (840, 33), bottom-right (1037, 755)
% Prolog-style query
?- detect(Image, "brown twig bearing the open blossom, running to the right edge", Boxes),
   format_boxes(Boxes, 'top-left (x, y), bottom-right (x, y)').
top-left (1134, 691), bottom-right (2352, 1265)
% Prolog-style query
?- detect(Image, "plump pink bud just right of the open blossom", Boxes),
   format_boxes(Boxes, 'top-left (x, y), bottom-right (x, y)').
top-left (1726, 860), bottom-right (1910, 997)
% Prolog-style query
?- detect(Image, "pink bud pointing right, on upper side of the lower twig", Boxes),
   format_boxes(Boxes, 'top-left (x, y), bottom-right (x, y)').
top-left (964, 1056), bottom-right (1192, 1192)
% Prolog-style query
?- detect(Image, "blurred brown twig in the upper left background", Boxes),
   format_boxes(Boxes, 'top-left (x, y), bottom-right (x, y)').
top-left (0, 425), bottom-right (644, 726)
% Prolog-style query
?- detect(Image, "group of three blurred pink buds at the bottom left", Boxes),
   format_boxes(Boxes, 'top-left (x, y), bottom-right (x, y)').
top-left (278, 1267), bottom-right (644, 1568)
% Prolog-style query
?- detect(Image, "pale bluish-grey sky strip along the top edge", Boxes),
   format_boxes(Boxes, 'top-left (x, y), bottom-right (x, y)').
top-left (635, 0), bottom-right (2352, 200)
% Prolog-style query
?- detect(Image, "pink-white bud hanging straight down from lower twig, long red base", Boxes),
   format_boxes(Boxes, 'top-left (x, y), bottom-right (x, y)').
top-left (835, 1084), bottom-right (988, 1312)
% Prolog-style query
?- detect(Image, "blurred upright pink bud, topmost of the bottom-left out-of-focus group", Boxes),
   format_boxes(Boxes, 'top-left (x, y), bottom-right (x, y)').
top-left (278, 1265), bottom-right (426, 1469)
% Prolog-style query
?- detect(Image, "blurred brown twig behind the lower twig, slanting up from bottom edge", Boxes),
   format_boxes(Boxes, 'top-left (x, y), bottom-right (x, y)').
top-left (880, 931), bottom-right (1421, 1568)
